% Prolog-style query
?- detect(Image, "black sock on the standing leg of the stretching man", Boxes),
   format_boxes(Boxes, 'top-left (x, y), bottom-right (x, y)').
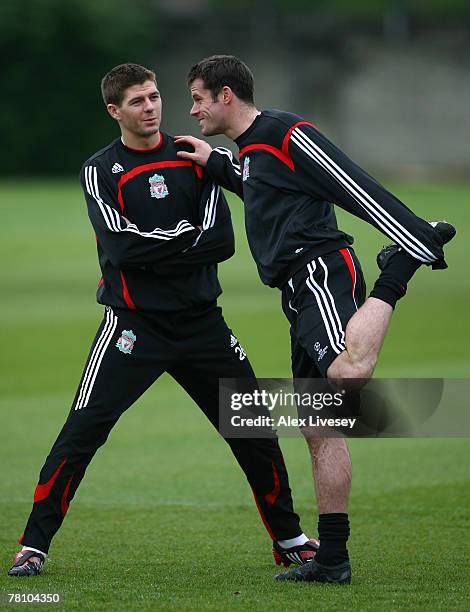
top-left (315, 512), bottom-right (349, 565)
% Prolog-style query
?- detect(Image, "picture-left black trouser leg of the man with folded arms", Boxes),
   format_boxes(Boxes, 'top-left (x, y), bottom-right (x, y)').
top-left (20, 309), bottom-right (164, 553)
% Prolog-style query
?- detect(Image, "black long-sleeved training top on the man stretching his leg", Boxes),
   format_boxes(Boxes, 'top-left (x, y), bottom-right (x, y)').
top-left (207, 110), bottom-right (444, 287)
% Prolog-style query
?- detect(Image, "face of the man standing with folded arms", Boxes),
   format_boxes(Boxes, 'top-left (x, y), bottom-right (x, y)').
top-left (108, 81), bottom-right (162, 138)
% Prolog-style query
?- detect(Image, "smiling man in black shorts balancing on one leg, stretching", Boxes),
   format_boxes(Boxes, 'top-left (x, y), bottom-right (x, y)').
top-left (177, 55), bottom-right (455, 583)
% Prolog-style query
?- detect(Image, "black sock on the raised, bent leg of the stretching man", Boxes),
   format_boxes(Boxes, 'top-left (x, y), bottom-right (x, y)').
top-left (370, 251), bottom-right (421, 308)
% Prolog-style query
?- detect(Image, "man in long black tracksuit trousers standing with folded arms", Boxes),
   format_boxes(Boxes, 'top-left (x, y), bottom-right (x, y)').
top-left (9, 64), bottom-right (317, 576)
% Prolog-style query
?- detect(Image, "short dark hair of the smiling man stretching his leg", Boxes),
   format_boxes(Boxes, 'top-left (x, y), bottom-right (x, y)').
top-left (188, 55), bottom-right (254, 104)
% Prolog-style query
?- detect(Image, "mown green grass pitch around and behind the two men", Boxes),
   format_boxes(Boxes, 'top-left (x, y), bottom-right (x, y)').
top-left (0, 180), bottom-right (470, 611)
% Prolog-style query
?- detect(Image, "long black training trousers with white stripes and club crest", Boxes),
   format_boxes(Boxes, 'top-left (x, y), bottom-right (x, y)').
top-left (20, 304), bottom-right (302, 553)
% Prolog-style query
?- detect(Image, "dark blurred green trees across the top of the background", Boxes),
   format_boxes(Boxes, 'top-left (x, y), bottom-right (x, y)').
top-left (0, 0), bottom-right (470, 175)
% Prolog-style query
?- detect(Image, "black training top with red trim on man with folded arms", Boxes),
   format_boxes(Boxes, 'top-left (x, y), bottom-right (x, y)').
top-left (80, 133), bottom-right (234, 312)
